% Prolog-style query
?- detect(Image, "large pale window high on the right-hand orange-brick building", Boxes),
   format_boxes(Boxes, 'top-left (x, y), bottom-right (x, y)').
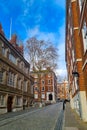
top-left (82, 22), bottom-right (87, 52)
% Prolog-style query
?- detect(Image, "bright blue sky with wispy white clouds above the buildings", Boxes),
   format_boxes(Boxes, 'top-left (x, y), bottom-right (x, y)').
top-left (0, 0), bottom-right (66, 78)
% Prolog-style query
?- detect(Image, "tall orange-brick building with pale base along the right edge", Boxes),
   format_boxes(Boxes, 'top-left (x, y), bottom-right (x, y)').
top-left (65, 0), bottom-right (87, 121)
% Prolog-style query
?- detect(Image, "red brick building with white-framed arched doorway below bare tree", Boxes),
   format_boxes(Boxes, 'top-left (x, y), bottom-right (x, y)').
top-left (31, 70), bottom-right (57, 103)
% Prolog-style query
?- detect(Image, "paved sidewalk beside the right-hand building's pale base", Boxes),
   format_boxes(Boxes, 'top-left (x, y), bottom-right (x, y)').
top-left (64, 103), bottom-right (87, 130)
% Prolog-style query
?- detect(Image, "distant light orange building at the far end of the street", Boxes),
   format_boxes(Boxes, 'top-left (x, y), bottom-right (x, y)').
top-left (57, 80), bottom-right (69, 100)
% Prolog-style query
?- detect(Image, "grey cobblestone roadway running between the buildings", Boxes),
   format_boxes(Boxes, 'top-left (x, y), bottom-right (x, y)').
top-left (0, 103), bottom-right (62, 130)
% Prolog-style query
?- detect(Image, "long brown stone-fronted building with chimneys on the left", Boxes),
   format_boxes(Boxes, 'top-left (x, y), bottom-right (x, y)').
top-left (0, 25), bottom-right (33, 114)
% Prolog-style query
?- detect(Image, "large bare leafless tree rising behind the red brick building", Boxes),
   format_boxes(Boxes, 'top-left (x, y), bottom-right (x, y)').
top-left (26, 37), bottom-right (58, 71)
